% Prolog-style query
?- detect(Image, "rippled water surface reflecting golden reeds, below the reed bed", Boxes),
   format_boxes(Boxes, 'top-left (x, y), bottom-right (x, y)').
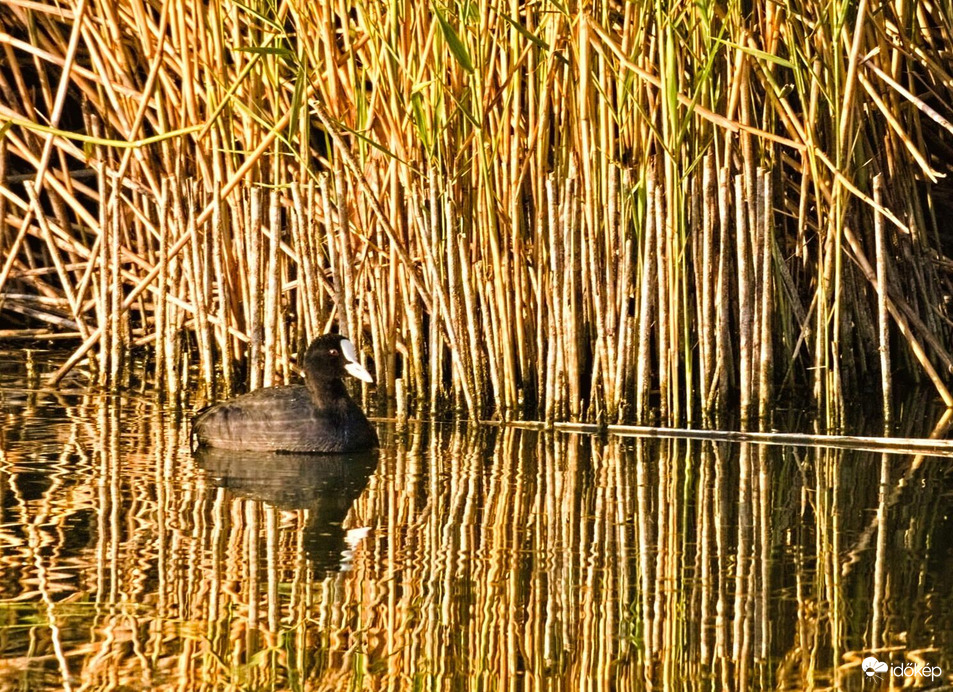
top-left (0, 353), bottom-right (953, 691)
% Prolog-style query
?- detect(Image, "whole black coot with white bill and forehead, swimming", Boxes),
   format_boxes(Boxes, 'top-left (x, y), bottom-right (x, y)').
top-left (192, 334), bottom-right (378, 454)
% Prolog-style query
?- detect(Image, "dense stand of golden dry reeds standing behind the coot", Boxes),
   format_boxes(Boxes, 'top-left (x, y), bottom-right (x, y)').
top-left (0, 0), bottom-right (953, 424)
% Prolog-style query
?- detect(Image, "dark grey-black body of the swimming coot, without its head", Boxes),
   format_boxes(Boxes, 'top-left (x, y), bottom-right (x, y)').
top-left (192, 383), bottom-right (377, 454)
